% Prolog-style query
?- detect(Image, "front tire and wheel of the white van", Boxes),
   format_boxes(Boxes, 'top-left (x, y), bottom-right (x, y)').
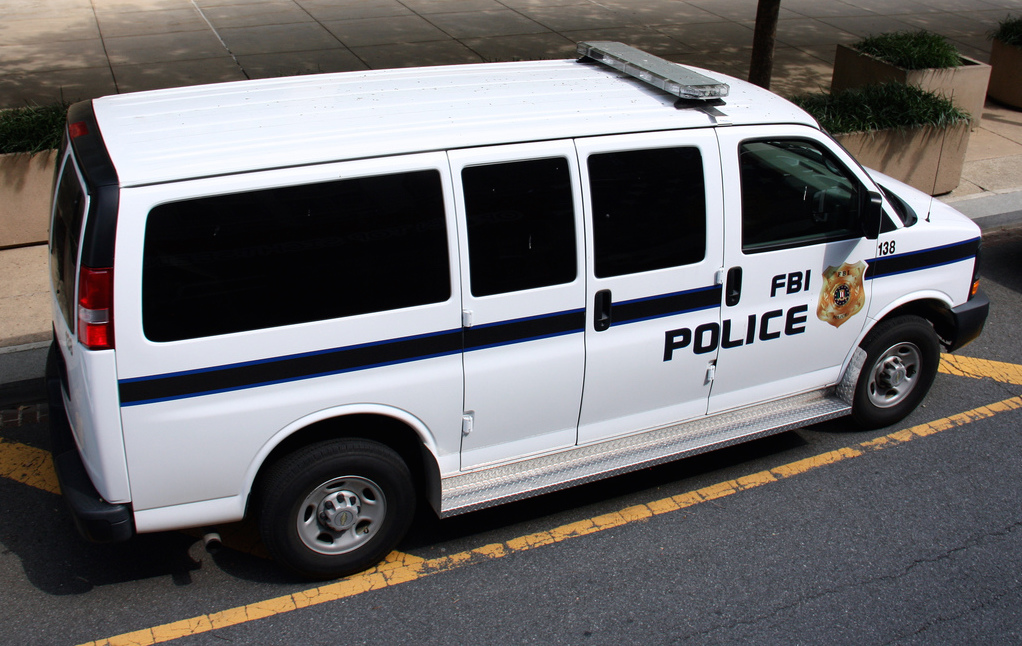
top-left (851, 316), bottom-right (940, 428)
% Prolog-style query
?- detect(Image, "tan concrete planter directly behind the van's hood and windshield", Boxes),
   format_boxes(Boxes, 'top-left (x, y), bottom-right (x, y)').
top-left (834, 122), bottom-right (971, 195)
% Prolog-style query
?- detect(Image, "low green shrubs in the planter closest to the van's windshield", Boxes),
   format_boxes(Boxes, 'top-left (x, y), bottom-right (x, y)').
top-left (791, 83), bottom-right (969, 135)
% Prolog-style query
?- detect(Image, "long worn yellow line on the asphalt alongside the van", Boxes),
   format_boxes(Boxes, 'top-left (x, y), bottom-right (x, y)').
top-left (83, 397), bottom-right (1022, 646)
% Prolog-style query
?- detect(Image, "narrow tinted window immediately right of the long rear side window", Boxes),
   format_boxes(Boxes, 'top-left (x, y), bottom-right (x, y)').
top-left (462, 158), bottom-right (577, 296)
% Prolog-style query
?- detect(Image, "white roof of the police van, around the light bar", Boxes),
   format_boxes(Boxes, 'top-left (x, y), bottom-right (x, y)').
top-left (93, 55), bottom-right (817, 186)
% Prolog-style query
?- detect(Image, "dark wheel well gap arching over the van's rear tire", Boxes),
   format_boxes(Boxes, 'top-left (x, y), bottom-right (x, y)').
top-left (245, 414), bottom-right (440, 515)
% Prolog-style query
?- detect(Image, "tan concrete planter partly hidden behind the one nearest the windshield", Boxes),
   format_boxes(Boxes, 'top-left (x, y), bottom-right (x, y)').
top-left (831, 45), bottom-right (990, 128)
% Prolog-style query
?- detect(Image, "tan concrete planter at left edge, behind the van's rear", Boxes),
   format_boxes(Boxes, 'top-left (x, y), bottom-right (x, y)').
top-left (0, 150), bottom-right (57, 248)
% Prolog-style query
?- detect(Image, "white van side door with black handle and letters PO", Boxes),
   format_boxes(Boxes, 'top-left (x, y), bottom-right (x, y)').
top-left (576, 130), bottom-right (723, 444)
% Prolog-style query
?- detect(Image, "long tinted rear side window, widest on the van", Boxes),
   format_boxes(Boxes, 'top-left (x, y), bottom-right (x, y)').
top-left (142, 171), bottom-right (451, 341)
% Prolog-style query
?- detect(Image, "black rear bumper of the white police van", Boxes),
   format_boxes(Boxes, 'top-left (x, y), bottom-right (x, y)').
top-left (46, 345), bottom-right (135, 543)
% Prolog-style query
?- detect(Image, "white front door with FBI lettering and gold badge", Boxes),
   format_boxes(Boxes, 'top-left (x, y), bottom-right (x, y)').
top-left (709, 126), bottom-right (876, 413)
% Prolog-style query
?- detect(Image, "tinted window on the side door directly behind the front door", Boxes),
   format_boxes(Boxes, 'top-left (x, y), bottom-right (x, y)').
top-left (589, 148), bottom-right (706, 278)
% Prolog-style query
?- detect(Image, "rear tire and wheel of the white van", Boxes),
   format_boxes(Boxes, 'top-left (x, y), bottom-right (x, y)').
top-left (257, 440), bottom-right (415, 580)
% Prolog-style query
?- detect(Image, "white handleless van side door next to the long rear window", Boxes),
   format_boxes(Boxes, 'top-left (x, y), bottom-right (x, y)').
top-left (450, 141), bottom-right (586, 469)
